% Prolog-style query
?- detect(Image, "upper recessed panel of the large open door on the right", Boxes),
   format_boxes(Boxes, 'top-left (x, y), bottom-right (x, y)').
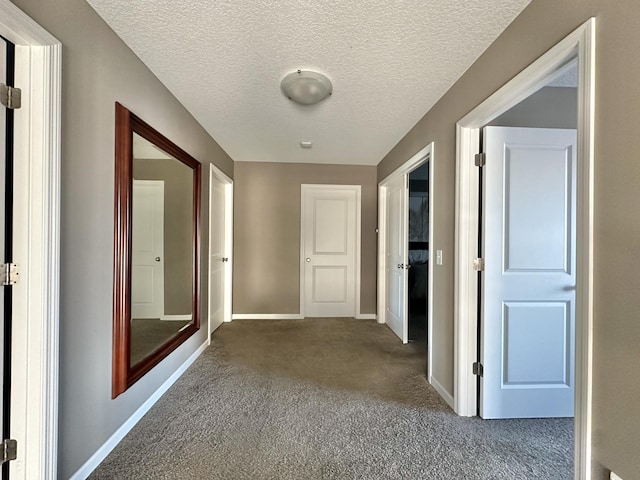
top-left (503, 143), bottom-right (572, 272)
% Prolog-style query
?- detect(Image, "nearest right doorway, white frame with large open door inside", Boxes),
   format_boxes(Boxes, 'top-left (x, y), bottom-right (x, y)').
top-left (454, 19), bottom-right (595, 478)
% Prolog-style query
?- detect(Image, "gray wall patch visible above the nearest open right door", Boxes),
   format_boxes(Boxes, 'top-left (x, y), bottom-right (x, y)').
top-left (489, 87), bottom-right (578, 128)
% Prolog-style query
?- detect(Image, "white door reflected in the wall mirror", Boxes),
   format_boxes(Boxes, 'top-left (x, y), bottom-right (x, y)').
top-left (131, 180), bottom-right (164, 319)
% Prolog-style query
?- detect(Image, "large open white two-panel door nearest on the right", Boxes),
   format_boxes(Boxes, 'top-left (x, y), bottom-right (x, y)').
top-left (480, 127), bottom-right (576, 418)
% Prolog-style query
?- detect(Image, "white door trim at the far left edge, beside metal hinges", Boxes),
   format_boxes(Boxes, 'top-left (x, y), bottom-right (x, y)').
top-left (0, 0), bottom-right (62, 480)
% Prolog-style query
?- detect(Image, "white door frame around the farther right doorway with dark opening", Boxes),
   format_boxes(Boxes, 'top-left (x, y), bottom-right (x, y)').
top-left (377, 142), bottom-right (435, 352)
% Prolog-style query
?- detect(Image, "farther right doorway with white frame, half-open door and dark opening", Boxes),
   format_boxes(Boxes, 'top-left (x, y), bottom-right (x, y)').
top-left (378, 143), bottom-right (436, 376)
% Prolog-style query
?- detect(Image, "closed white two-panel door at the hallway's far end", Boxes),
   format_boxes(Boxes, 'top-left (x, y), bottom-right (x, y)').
top-left (300, 185), bottom-right (360, 317)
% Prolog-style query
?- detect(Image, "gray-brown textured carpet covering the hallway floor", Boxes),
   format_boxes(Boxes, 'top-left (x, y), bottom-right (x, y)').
top-left (90, 319), bottom-right (573, 480)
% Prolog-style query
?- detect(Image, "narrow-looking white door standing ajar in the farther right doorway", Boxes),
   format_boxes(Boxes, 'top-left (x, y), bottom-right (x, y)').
top-left (385, 175), bottom-right (409, 343)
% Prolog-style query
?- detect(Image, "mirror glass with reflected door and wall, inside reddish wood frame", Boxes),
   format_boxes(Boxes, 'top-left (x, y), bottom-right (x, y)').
top-left (130, 133), bottom-right (193, 366)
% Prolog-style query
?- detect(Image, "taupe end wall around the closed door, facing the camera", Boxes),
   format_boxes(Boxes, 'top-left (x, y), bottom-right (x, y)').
top-left (233, 162), bottom-right (377, 314)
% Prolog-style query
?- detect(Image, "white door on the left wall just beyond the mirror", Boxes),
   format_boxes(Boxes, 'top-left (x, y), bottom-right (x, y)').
top-left (209, 175), bottom-right (228, 332)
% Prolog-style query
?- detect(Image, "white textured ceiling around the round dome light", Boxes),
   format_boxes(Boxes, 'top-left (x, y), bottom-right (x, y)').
top-left (88, 0), bottom-right (530, 165)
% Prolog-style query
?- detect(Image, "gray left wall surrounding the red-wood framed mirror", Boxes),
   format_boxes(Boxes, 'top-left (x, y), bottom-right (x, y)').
top-left (14, 0), bottom-right (233, 479)
